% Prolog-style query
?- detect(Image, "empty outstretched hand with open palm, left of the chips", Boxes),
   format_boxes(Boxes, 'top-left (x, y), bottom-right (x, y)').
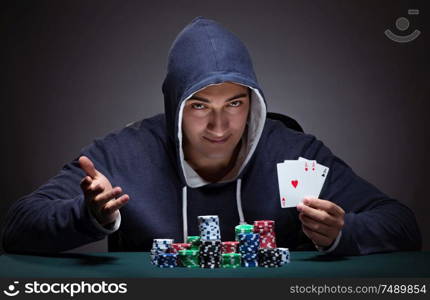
top-left (79, 156), bottom-right (130, 226)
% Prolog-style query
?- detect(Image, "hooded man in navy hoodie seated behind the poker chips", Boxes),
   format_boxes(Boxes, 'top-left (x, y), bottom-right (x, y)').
top-left (3, 17), bottom-right (421, 255)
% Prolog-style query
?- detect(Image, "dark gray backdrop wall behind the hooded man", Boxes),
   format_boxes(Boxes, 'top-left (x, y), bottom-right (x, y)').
top-left (0, 0), bottom-right (430, 251)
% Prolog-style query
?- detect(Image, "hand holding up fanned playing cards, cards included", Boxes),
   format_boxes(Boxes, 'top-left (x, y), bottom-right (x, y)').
top-left (277, 157), bottom-right (345, 248)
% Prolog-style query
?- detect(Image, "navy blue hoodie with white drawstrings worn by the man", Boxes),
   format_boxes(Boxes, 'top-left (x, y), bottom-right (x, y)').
top-left (3, 17), bottom-right (421, 255)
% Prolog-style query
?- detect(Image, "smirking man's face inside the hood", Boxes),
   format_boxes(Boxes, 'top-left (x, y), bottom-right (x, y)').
top-left (182, 82), bottom-right (250, 159)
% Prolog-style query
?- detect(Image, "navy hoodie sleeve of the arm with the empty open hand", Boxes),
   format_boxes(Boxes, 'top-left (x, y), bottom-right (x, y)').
top-left (3, 140), bottom-right (120, 253)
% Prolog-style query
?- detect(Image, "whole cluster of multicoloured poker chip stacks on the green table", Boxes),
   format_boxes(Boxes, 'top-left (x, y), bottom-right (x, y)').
top-left (151, 216), bottom-right (290, 268)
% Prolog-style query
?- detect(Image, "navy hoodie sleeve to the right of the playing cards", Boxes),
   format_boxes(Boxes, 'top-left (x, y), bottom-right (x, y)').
top-left (305, 136), bottom-right (422, 255)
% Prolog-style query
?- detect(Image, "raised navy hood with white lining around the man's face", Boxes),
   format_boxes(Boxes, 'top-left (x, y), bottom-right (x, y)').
top-left (162, 17), bottom-right (266, 188)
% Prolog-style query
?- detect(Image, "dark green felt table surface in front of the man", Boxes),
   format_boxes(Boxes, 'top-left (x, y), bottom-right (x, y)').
top-left (0, 252), bottom-right (430, 278)
